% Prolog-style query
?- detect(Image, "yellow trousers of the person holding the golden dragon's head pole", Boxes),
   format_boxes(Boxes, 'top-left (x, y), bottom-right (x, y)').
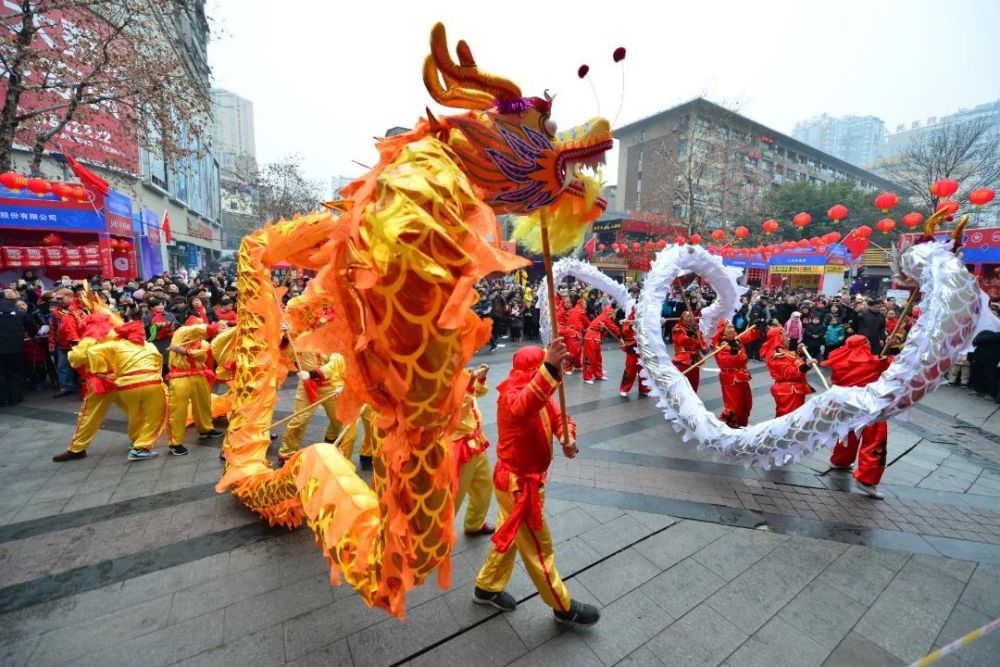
top-left (476, 488), bottom-right (572, 611)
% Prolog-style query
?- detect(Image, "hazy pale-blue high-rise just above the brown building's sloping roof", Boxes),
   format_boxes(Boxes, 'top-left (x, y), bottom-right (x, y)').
top-left (792, 114), bottom-right (885, 167)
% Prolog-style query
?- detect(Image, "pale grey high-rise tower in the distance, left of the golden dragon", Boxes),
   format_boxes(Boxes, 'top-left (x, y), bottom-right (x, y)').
top-left (212, 88), bottom-right (257, 181)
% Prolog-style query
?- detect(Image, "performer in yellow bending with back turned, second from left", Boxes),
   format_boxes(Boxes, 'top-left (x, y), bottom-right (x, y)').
top-left (87, 321), bottom-right (167, 461)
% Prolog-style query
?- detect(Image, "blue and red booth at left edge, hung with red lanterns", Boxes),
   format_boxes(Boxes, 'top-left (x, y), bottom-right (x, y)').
top-left (0, 178), bottom-right (137, 283)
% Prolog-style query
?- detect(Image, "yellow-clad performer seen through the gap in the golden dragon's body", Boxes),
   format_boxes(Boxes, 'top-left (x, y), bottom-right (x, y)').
top-left (278, 352), bottom-right (357, 462)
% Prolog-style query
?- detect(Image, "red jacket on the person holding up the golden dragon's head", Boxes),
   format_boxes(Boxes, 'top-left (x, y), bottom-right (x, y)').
top-left (497, 366), bottom-right (576, 475)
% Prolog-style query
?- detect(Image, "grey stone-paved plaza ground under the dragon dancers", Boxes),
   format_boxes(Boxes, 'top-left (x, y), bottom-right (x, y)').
top-left (0, 346), bottom-right (1000, 667)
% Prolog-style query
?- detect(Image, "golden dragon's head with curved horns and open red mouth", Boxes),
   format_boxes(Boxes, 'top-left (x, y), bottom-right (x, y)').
top-left (424, 23), bottom-right (613, 220)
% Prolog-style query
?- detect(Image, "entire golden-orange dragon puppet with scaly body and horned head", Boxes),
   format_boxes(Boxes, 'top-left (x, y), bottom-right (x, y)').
top-left (216, 24), bottom-right (612, 618)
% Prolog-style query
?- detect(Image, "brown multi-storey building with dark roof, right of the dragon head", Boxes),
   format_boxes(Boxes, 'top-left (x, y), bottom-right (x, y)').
top-left (615, 98), bottom-right (896, 231)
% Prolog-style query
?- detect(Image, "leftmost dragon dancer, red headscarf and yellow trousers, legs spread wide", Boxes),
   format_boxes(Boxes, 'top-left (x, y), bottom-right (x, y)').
top-left (52, 313), bottom-right (125, 463)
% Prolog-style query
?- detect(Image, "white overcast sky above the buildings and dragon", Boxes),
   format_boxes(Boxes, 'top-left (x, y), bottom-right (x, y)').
top-left (208, 0), bottom-right (1000, 196)
